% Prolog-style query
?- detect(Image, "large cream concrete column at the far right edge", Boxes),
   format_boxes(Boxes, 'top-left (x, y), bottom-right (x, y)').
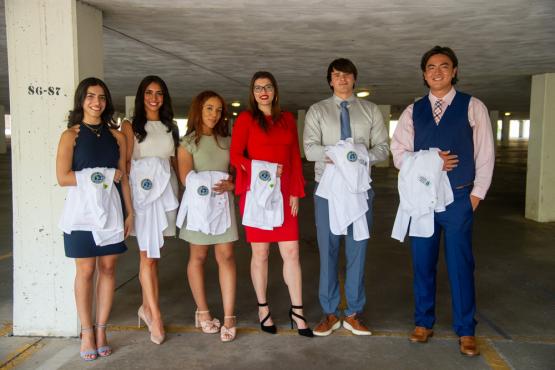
top-left (525, 73), bottom-right (555, 222)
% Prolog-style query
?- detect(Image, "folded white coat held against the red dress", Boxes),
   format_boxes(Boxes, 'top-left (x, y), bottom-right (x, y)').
top-left (242, 160), bottom-right (283, 230)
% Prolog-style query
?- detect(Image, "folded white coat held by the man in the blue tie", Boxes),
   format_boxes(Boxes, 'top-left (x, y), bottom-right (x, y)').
top-left (316, 138), bottom-right (372, 241)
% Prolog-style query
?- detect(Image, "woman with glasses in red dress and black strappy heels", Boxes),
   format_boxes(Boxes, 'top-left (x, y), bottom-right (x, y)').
top-left (230, 72), bottom-right (313, 337)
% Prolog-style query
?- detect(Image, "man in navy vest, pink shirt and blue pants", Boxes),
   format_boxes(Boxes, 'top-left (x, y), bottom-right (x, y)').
top-left (391, 46), bottom-right (495, 356)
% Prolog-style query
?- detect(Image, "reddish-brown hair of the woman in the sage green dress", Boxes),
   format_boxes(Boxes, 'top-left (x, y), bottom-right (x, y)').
top-left (187, 90), bottom-right (229, 147)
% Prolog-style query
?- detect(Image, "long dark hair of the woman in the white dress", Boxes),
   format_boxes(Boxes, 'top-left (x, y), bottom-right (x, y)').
top-left (132, 76), bottom-right (179, 148)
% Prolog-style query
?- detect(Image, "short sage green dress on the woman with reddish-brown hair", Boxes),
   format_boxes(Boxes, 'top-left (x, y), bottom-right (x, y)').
top-left (179, 135), bottom-right (239, 245)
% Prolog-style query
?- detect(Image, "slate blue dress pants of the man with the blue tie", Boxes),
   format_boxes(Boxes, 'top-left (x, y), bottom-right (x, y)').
top-left (314, 183), bottom-right (374, 316)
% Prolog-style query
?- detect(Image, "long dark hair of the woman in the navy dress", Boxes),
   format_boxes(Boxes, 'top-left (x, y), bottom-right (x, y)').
top-left (67, 77), bottom-right (118, 128)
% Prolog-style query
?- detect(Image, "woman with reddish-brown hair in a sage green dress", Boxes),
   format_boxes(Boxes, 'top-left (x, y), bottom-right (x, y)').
top-left (177, 91), bottom-right (238, 342)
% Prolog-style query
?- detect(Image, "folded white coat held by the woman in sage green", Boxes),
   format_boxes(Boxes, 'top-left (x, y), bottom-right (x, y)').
top-left (176, 171), bottom-right (231, 235)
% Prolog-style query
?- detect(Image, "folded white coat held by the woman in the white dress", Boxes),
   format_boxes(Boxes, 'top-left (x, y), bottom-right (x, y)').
top-left (129, 157), bottom-right (179, 258)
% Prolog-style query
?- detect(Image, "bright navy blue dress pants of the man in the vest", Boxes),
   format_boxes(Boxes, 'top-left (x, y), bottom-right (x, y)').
top-left (411, 186), bottom-right (476, 336)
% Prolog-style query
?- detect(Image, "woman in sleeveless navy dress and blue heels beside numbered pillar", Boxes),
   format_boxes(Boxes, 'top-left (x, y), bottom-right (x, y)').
top-left (56, 77), bottom-right (133, 361)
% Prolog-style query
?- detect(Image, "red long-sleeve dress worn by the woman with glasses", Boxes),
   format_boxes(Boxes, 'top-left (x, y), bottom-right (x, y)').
top-left (230, 111), bottom-right (305, 243)
